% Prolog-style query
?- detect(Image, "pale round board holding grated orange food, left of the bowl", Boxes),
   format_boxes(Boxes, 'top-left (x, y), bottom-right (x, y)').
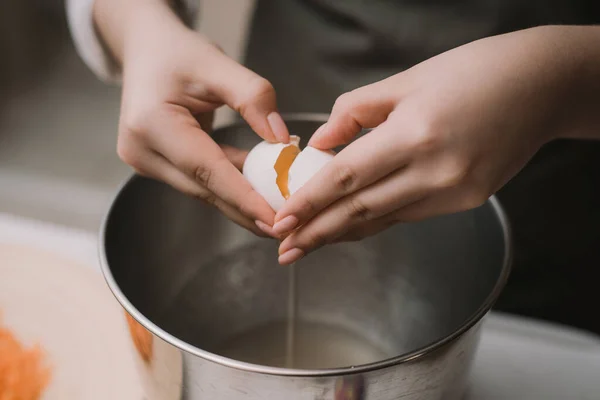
top-left (0, 242), bottom-right (182, 400)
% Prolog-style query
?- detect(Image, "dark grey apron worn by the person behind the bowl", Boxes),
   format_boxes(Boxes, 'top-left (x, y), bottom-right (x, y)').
top-left (241, 0), bottom-right (600, 333)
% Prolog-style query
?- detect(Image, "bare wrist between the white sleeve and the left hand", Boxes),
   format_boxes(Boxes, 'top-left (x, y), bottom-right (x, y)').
top-left (93, 0), bottom-right (186, 66)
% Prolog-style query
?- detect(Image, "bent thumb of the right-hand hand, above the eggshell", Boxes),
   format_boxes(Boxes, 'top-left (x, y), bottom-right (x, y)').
top-left (308, 81), bottom-right (395, 150)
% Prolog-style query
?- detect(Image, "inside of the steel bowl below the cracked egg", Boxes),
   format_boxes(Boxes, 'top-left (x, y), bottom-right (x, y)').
top-left (103, 117), bottom-right (508, 368)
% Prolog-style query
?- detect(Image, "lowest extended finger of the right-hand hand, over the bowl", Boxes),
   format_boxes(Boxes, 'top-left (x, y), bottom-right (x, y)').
top-left (279, 169), bottom-right (430, 262)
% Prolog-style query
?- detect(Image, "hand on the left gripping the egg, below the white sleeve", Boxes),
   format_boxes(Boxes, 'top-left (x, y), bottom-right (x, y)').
top-left (94, 0), bottom-right (289, 236)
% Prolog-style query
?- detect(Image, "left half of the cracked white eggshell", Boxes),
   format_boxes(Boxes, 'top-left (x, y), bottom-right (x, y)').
top-left (242, 136), bottom-right (300, 211)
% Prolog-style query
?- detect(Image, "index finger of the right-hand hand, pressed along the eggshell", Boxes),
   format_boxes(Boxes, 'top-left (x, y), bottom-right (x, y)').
top-left (273, 120), bottom-right (410, 233)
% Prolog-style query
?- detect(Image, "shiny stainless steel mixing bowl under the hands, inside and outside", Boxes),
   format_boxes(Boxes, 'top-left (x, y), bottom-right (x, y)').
top-left (101, 115), bottom-right (510, 400)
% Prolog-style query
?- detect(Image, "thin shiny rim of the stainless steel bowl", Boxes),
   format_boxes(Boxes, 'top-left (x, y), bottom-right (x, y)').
top-left (98, 113), bottom-right (513, 377)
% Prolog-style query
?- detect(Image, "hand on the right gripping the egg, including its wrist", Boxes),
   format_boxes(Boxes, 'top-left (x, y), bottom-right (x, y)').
top-left (274, 24), bottom-right (598, 264)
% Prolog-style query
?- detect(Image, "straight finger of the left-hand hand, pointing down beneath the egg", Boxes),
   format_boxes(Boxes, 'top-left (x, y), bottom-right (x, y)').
top-left (147, 111), bottom-right (275, 226)
